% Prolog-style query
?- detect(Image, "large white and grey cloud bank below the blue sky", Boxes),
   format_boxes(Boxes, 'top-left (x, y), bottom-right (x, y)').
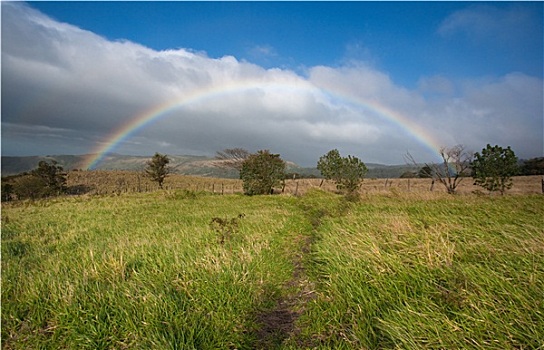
top-left (2, 2), bottom-right (543, 166)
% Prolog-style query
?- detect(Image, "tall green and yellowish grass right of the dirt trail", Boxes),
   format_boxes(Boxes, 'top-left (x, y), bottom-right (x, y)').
top-left (300, 191), bottom-right (544, 349)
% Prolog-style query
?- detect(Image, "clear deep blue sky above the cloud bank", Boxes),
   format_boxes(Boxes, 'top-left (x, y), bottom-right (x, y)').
top-left (26, 2), bottom-right (543, 86)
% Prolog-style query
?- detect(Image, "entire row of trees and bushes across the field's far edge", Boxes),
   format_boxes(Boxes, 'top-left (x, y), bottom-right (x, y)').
top-left (2, 144), bottom-right (544, 201)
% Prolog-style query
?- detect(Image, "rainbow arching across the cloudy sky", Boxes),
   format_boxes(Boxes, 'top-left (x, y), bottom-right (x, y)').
top-left (83, 80), bottom-right (440, 169)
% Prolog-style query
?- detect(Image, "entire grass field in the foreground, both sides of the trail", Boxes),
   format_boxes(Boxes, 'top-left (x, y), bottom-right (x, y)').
top-left (1, 187), bottom-right (544, 349)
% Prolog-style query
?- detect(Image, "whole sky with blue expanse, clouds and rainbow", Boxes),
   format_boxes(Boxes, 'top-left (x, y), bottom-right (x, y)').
top-left (1, 1), bottom-right (544, 166)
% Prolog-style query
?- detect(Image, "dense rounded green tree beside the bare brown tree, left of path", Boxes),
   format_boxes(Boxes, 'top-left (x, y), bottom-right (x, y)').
top-left (240, 150), bottom-right (285, 195)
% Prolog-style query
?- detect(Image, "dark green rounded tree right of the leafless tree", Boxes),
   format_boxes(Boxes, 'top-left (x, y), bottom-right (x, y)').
top-left (472, 144), bottom-right (519, 195)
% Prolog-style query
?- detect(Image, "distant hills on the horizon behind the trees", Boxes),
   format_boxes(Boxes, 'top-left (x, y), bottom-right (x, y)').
top-left (2, 154), bottom-right (414, 178)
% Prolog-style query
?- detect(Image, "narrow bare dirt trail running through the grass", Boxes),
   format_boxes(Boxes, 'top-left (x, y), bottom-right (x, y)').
top-left (256, 235), bottom-right (314, 349)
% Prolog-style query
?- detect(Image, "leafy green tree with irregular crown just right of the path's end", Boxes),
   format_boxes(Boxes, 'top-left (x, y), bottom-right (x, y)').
top-left (317, 149), bottom-right (368, 194)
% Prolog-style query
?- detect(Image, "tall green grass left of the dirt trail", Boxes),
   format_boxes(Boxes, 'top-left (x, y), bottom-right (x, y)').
top-left (2, 192), bottom-right (301, 349)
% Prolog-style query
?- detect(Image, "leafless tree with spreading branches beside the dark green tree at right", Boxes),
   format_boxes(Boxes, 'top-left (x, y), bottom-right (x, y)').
top-left (406, 145), bottom-right (473, 194)
